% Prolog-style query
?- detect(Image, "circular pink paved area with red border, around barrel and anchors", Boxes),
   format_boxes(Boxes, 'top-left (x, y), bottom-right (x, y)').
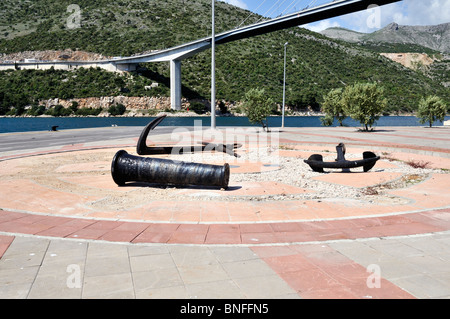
top-left (0, 139), bottom-right (450, 244)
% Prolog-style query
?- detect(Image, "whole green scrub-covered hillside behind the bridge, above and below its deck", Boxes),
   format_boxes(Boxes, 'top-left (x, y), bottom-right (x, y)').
top-left (0, 0), bottom-right (450, 112)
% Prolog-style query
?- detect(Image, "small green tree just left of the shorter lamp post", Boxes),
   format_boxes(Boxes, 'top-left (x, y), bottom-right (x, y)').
top-left (243, 89), bottom-right (275, 131)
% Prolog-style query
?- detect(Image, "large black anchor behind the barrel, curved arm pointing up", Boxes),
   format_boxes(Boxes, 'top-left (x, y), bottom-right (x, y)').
top-left (136, 115), bottom-right (242, 157)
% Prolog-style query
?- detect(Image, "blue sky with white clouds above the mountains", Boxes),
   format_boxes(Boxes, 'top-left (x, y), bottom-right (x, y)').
top-left (220, 0), bottom-right (450, 33)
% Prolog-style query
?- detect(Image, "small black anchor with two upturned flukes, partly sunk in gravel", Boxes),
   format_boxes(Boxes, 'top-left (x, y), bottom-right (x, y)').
top-left (305, 143), bottom-right (380, 173)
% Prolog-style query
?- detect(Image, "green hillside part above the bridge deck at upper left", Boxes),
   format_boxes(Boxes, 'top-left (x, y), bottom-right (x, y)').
top-left (0, 0), bottom-right (254, 56)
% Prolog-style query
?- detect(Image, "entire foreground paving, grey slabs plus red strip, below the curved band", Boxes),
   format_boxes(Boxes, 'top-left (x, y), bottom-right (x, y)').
top-left (0, 232), bottom-right (450, 299)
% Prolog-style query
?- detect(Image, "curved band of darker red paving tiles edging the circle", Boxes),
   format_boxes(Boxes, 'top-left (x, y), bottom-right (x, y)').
top-left (0, 209), bottom-right (450, 246)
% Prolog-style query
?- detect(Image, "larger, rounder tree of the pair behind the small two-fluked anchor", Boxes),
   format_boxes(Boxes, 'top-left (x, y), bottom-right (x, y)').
top-left (342, 83), bottom-right (387, 131)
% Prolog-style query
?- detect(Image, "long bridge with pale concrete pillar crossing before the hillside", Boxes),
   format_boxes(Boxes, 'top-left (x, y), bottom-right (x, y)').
top-left (0, 0), bottom-right (401, 110)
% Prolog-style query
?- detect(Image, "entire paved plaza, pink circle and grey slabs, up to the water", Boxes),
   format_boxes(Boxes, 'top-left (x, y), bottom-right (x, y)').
top-left (0, 127), bottom-right (450, 299)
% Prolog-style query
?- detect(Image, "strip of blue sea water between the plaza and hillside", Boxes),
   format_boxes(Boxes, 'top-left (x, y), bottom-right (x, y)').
top-left (0, 116), bottom-right (450, 133)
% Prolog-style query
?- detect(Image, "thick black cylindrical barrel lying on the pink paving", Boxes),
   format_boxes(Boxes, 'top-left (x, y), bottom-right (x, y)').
top-left (111, 150), bottom-right (230, 188)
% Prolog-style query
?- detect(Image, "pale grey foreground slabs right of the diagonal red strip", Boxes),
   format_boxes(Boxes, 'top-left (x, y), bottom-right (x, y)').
top-left (330, 232), bottom-right (450, 299)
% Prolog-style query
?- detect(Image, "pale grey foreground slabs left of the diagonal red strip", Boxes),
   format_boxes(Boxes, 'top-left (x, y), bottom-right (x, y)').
top-left (0, 237), bottom-right (296, 299)
